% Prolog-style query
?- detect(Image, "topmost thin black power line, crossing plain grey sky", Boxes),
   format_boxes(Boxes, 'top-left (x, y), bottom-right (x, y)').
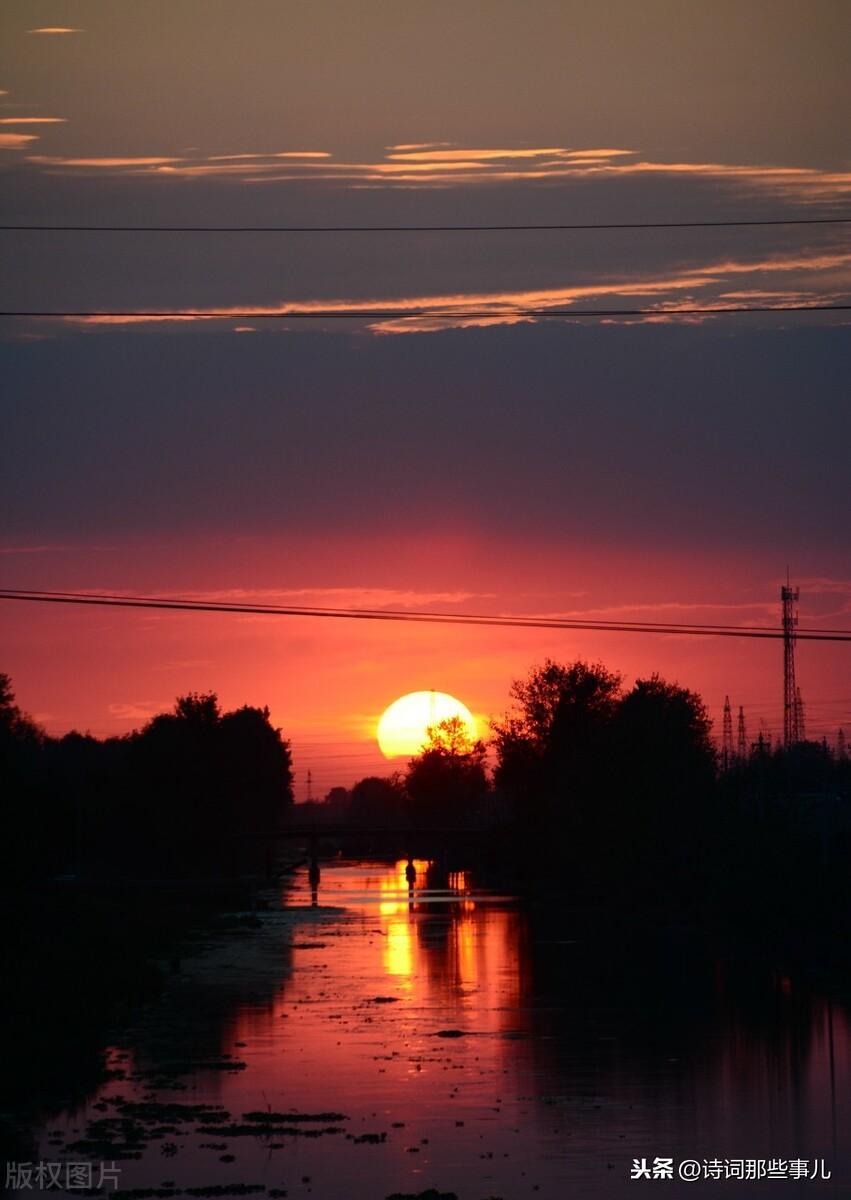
top-left (0, 217), bottom-right (851, 234)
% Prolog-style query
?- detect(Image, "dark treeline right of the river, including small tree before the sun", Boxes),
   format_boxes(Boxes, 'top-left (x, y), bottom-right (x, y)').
top-left (302, 660), bottom-right (851, 928)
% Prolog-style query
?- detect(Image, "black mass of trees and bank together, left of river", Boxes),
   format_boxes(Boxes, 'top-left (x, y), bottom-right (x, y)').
top-left (0, 676), bottom-right (293, 1159)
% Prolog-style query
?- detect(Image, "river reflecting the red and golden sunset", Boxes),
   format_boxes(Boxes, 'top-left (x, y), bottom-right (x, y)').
top-left (29, 862), bottom-right (851, 1200)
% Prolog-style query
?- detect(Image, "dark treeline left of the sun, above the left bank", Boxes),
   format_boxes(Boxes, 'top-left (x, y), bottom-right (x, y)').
top-left (0, 676), bottom-right (293, 881)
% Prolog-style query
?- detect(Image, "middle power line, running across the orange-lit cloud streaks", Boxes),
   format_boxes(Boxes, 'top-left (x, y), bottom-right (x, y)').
top-left (0, 304), bottom-right (851, 320)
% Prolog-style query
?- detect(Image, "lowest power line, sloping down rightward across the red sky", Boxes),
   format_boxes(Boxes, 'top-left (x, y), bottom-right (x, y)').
top-left (6, 588), bottom-right (851, 642)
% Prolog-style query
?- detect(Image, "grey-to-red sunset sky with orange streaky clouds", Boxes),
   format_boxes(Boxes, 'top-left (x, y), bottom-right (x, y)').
top-left (0, 0), bottom-right (851, 798)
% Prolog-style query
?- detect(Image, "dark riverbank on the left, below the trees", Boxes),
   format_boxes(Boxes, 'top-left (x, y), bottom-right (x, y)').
top-left (0, 880), bottom-right (272, 1159)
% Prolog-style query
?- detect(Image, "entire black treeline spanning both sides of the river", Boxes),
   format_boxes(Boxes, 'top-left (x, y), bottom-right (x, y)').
top-left (0, 660), bottom-right (851, 911)
